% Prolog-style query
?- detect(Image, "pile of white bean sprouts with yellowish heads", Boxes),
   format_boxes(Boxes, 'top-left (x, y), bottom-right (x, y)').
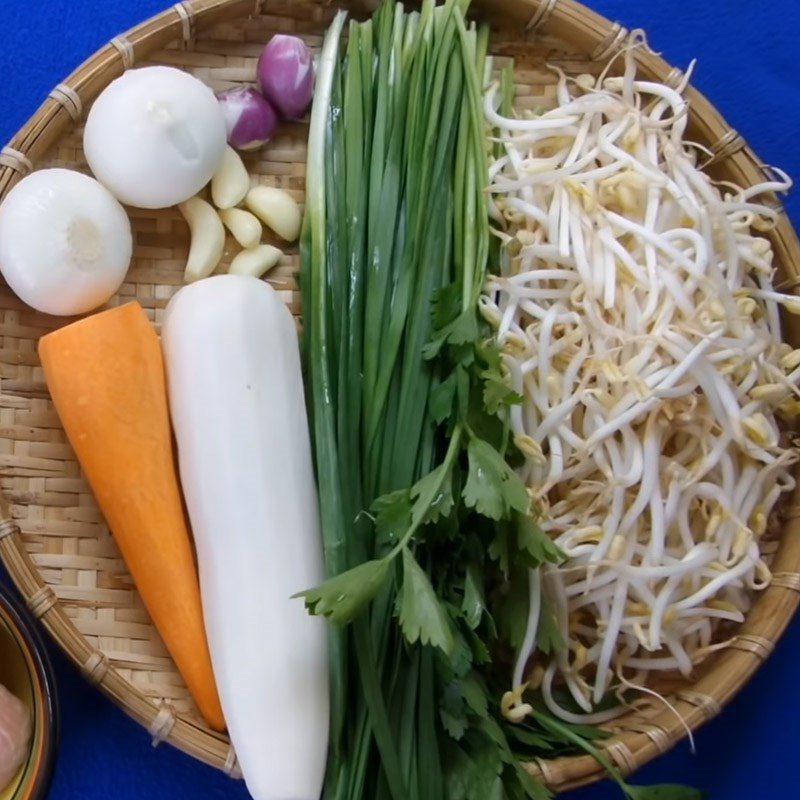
top-left (481, 41), bottom-right (800, 724)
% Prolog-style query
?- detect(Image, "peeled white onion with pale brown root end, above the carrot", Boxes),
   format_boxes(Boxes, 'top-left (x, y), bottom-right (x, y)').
top-left (0, 169), bottom-right (133, 316)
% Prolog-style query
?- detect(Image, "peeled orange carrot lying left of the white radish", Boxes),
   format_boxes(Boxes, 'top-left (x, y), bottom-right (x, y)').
top-left (39, 303), bottom-right (225, 730)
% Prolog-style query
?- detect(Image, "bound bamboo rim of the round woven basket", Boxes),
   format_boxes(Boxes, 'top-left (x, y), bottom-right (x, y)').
top-left (0, 0), bottom-right (800, 791)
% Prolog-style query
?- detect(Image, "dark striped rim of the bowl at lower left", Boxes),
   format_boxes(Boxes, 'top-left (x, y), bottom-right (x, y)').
top-left (0, 583), bottom-right (61, 800)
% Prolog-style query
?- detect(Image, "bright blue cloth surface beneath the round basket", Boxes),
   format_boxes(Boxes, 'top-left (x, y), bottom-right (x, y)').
top-left (0, 0), bottom-right (800, 800)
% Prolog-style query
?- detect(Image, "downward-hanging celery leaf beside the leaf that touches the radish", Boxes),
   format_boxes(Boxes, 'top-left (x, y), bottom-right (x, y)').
top-left (398, 547), bottom-right (453, 653)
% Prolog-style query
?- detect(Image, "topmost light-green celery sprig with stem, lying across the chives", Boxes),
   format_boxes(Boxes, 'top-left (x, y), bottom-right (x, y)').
top-left (300, 316), bottom-right (561, 653)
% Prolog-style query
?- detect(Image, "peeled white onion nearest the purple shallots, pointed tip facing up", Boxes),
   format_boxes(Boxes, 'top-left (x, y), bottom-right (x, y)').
top-left (83, 67), bottom-right (227, 208)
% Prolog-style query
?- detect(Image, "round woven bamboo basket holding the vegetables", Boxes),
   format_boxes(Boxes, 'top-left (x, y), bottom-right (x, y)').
top-left (0, 0), bottom-right (800, 790)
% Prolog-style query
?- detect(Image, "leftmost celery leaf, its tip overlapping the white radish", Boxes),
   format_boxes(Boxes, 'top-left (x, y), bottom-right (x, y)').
top-left (294, 558), bottom-right (392, 625)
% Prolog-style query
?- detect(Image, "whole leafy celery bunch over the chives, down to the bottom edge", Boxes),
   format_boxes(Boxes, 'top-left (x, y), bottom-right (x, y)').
top-left (302, 284), bottom-right (562, 800)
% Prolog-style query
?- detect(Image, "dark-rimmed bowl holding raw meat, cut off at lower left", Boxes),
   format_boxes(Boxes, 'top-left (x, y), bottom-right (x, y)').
top-left (0, 585), bottom-right (58, 800)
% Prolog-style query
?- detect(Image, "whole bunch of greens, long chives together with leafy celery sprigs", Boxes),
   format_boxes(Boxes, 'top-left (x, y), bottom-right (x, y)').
top-left (301, 0), bottom-right (708, 800)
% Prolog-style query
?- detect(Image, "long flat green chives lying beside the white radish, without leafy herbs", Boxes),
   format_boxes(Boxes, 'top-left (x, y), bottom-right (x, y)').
top-left (301, 0), bottom-right (506, 800)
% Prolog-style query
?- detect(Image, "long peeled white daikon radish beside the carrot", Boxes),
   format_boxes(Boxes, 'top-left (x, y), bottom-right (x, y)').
top-left (161, 275), bottom-right (328, 800)
